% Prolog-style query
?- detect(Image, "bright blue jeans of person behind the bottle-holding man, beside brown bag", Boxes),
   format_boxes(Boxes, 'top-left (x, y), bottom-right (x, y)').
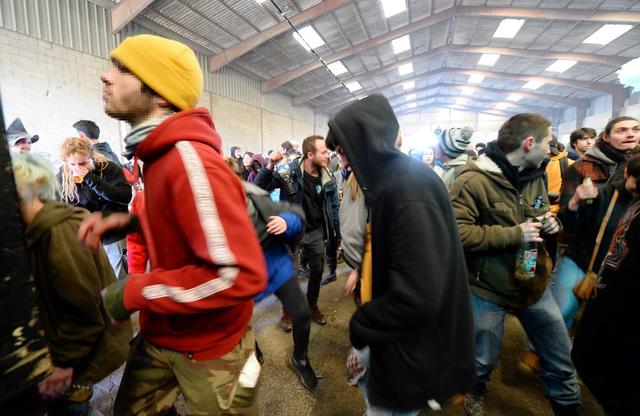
top-left (550, 256), bottom-right (584, 328)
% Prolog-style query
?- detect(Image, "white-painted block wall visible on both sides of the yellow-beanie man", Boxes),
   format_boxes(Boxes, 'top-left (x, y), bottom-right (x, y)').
top-left (0, 28), bottom-right (327, 165)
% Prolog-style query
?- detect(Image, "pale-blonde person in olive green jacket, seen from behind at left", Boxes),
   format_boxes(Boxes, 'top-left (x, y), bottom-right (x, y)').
top-left (12, 154), bottom-right (132, 416)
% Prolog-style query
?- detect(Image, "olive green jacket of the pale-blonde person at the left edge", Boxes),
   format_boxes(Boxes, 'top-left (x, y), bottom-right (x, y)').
top-left (27, 201), bottom-right (132, 382)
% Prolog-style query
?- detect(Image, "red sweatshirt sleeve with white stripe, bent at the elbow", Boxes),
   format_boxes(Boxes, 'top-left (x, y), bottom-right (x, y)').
top-left (125, 141), bottom-right (266, 313)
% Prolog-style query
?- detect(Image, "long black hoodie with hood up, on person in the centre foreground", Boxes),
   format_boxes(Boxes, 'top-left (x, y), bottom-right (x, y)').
top-left (327, 95), bottom-right (475, 415)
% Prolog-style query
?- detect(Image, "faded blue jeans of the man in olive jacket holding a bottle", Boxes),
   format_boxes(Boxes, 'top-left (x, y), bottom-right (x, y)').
top-left (471, 288), bottom-right (580, 406)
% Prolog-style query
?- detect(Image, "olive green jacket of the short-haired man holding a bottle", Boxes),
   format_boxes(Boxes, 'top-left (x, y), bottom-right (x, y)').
top-left (451, 156), bottom-right (552, 308)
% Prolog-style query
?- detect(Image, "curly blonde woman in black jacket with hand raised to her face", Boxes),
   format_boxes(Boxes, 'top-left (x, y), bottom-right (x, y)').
top-left (58, 137), bottom-right (131, 279)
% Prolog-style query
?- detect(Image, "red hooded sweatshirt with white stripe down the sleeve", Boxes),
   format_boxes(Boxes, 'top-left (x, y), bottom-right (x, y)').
top-left (124, 108), bottom-right (267, 360)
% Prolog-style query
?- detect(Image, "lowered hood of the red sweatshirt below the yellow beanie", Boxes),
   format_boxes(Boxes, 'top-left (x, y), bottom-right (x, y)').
top-left (135, 107), bottom-right (222, 162)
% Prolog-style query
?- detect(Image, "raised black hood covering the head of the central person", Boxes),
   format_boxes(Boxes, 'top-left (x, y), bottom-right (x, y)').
top-left (327, 95), bottom-right (406, 205)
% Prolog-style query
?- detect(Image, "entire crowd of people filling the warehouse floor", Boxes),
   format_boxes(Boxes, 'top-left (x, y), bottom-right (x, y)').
top-left (3, 35), bottom-right (640, 416)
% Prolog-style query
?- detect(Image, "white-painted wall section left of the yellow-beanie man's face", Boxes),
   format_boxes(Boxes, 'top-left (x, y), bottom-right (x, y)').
top-left (0, 29), bottom-right (121, 160)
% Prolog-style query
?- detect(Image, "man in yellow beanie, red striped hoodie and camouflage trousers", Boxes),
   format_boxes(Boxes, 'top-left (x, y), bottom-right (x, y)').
top-left (79, 35), bottom-right (267, 415)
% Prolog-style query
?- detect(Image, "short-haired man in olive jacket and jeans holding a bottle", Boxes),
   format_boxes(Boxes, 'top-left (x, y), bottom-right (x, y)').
top-left (451, 114), bottom-right (580, 416)
